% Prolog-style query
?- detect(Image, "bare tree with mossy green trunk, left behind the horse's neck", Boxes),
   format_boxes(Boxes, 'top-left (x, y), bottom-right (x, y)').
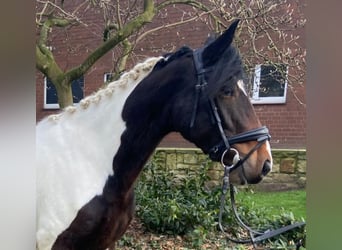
top-left (36, 0), bottom-right (216, 108)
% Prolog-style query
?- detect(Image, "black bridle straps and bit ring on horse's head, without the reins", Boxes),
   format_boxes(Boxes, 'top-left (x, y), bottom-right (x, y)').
top-left (190, 49), bottom-right (271, 171)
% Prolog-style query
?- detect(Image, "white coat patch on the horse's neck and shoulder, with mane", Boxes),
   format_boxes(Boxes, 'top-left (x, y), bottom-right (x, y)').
top-left (36, 57), bottom-right (161, 250)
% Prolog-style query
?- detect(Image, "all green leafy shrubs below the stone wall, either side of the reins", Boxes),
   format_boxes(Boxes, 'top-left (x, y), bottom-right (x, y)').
top-left (136, 157), bottom-right (305, 249)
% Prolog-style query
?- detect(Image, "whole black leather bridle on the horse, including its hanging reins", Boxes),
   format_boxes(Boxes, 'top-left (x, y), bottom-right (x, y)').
top-left (190, 48), bottom-right (305, 249)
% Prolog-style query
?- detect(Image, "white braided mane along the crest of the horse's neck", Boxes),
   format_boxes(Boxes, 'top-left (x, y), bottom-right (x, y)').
top-left (46, 57), bottom-right (165, 122)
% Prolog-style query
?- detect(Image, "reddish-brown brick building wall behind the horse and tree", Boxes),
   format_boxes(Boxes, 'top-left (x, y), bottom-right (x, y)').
top-left (36, 1), bottom-right (306, 149)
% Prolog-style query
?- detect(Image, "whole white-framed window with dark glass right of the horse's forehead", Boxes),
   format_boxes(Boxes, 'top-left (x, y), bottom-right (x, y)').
top-left (250, 64), bottom-right (288, 104)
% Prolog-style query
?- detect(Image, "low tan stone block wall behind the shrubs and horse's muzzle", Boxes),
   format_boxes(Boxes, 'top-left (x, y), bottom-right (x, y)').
top-left (151, 148), bottom-right (306, 191)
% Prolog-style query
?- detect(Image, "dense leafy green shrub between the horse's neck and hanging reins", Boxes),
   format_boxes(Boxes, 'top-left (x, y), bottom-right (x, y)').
top-left (136, 159), bottom-right (219, 235)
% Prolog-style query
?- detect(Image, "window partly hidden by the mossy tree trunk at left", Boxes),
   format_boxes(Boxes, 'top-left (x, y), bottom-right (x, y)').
top-left (44, 76), bottom-right (84, 109)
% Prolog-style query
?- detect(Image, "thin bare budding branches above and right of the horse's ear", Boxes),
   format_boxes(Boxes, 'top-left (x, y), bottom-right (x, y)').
top-left (210, 0), bottom-right (306, 104)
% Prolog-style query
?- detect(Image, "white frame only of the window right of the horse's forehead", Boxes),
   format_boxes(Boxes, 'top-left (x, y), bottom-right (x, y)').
top-left (251, 64), bottom-right (288, 104)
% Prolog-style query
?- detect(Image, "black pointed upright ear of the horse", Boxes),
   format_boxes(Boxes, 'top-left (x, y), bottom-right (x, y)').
top-left (202, 19), bottom-right (240, 67)
